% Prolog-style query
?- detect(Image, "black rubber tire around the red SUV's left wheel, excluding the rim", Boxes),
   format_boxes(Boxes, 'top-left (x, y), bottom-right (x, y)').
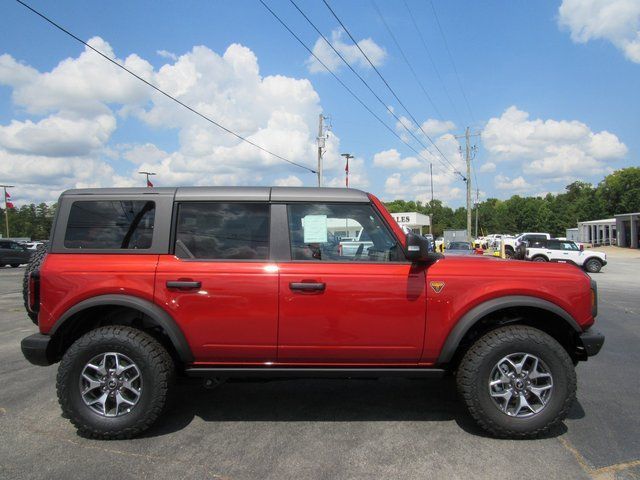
top-left (56, 325), bottom-right (175, 440)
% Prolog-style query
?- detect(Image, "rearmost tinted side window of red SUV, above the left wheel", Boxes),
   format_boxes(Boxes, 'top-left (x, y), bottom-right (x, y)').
top-left (64, 200), bottom-right (155, 250)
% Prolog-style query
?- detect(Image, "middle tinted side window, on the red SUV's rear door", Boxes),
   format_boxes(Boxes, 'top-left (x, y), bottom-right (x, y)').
top-left (176, 202), bottom-right (269, 260)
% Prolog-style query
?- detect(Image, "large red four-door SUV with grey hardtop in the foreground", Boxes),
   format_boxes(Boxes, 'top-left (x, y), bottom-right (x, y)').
top-left (22, 187), bottom-right (604, 438)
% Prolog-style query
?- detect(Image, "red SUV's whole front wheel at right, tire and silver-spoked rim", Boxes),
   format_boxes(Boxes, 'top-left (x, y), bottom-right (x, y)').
top-left (457, 325), bottom-right (576, 438)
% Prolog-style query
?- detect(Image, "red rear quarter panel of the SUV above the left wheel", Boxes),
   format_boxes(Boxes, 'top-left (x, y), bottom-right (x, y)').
top-left (38, 253), bottom-right (158, 333)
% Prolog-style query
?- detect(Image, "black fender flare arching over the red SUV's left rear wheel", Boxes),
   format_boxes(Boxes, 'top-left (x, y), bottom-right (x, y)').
top-left (49, 294), bottom-right (194, 363)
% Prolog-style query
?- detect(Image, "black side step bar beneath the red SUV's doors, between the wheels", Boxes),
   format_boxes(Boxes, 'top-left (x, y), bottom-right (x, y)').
top-left (185, 367), bottom-right (447, 378)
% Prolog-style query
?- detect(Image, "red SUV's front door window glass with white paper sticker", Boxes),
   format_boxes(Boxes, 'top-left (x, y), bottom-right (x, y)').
top-left (287, 203), bottom-right (405, 262)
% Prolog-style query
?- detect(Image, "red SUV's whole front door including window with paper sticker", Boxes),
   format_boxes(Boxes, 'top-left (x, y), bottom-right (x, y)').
top-left (278, 203), bottom-right (426, 365)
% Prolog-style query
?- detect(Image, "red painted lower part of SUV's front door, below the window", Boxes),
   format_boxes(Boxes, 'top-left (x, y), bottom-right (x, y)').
top-left (278, 262), bottom-right (426, 365)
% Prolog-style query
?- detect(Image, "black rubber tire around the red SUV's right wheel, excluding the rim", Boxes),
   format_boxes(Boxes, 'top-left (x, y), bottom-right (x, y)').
top-left (456, 325), bottom-right (576, 439)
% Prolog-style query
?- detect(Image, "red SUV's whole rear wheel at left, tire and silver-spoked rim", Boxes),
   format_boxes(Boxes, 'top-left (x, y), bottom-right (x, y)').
top-left (56, 326), bottom-right (175, 439)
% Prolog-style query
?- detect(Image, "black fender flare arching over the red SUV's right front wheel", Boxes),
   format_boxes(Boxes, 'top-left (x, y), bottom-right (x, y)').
top-left (437, 295), bottom-right (582, 364)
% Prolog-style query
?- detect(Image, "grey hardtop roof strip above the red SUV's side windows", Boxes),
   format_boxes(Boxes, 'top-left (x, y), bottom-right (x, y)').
top-left (61, 187), bottom-right (369, 202)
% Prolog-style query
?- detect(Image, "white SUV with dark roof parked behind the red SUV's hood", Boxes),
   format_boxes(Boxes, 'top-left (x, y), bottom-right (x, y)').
top-left (525, 239), bottom-right (607, 273)
